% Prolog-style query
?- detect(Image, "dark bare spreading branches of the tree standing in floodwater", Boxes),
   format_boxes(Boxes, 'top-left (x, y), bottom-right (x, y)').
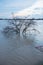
top-left (3, 19), bottom-right (39, 37)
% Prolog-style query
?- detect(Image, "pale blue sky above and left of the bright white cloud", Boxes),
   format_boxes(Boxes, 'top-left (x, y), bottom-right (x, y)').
top-left (0, 0), bottom-right (37, 18)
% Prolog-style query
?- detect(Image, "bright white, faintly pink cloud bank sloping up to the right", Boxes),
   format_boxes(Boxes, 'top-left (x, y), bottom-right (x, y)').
top-left (14, 0), bottom-right (43, 16)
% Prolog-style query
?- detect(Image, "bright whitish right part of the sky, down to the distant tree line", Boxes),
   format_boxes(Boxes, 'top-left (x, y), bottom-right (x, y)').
top-left (14, 0), bottom-right (43, 18)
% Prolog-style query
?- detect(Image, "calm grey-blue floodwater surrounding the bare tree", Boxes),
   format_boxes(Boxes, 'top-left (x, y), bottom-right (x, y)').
top-left (0, 20), bottom-right (43, 65)
